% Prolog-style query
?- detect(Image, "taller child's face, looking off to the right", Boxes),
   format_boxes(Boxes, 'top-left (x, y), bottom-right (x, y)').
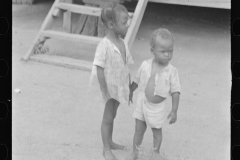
top-left (113, 11), bottom-right (129, 36)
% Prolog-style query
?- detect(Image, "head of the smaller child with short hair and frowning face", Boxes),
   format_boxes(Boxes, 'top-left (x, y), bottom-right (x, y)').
top-left (150, 28), bottom-right (174, 64)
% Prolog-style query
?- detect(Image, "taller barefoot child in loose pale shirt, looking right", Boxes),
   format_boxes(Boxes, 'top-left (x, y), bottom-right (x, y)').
top-left (89, 3), bottom-right (133, 160)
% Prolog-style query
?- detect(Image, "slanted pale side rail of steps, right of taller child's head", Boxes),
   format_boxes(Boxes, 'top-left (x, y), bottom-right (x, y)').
top-left (124, 0), bottom-right (148, 48)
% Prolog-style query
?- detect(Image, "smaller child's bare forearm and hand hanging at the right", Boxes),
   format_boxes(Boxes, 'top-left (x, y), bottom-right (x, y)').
top-left (168, 92), bottom-right (180, 124)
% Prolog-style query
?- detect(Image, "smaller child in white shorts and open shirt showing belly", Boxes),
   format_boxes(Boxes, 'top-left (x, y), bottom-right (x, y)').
top-left (129, 28), bottom-right (180, 160)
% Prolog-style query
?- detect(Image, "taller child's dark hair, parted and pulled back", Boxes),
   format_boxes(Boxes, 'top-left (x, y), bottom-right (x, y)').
top-left (101, 2), bottom-right (128, 26)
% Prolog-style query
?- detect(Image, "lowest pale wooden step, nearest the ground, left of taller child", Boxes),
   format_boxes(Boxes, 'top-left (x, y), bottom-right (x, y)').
top-left (30, 54), bottom-right (92, 72)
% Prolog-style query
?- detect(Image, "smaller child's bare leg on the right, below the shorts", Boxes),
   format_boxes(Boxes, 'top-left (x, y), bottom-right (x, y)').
top-left (152, 128), bottom-right (162, 158)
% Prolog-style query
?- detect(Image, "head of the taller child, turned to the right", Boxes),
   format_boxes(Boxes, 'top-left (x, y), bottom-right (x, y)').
top-left (101, 2), bottom-right (129, 36)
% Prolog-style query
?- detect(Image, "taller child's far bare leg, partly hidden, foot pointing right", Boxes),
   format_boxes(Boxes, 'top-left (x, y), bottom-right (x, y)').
top-left (109, 100), bottom-right (126, 150)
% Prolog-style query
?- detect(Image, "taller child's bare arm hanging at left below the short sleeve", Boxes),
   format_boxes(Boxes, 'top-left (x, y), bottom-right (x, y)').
top-left (97, 66), bottom-right (110, 98)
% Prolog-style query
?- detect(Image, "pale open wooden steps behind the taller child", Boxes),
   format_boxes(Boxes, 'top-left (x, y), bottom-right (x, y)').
top-left (22, 0), bottom-right (148, 71)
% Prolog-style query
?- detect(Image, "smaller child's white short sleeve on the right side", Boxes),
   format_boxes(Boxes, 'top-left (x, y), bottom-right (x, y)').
top-left (170, 68), bottom-right (181, 94)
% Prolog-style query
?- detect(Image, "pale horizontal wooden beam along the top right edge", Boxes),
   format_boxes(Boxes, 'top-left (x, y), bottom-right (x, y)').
top-left (149, 0), bottom-right (231, 9)
